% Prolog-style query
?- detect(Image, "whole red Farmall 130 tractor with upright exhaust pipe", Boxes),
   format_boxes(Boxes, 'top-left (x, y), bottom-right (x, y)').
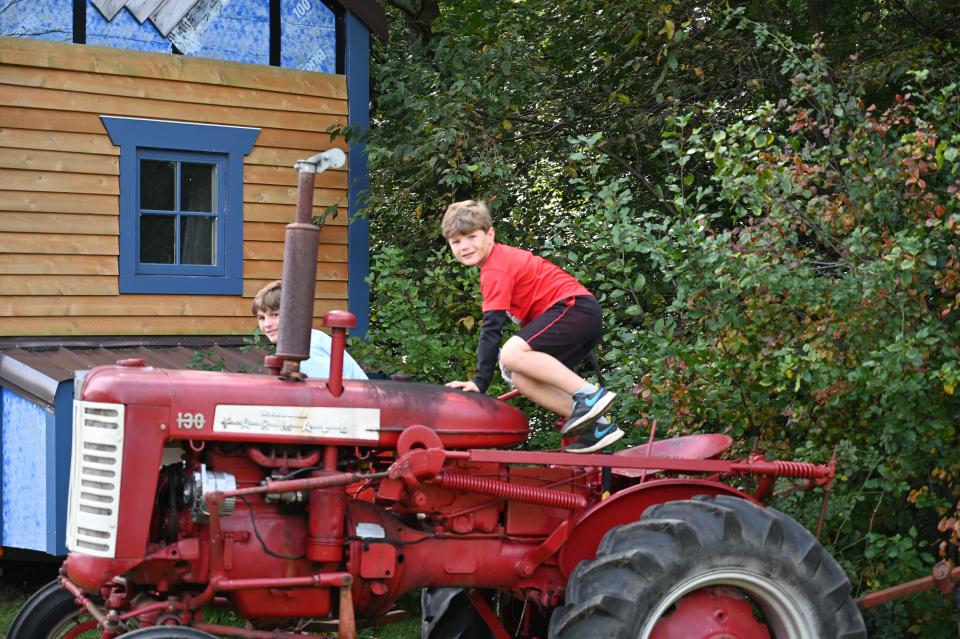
top-left (8, 154), bottom-right (866, 639)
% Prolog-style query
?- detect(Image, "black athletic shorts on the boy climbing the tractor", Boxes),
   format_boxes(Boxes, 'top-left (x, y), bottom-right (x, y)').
top-left (517, 295), bottom-right (603, 370)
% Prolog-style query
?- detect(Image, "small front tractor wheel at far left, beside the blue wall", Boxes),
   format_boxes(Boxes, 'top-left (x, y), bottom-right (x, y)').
top-left (7, 581), bottom-right (100, 639)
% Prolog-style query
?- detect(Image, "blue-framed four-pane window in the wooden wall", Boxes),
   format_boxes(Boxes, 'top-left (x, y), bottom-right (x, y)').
top-left (101, 116), bottom-right (260, 295)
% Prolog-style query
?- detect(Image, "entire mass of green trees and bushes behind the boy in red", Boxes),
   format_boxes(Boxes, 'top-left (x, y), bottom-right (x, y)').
top-left (352, 0), bottom-right (960, 637)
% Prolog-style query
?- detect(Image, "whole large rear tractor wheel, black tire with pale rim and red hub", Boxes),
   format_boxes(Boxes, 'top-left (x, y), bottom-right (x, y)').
top-left (549, 496), bottom-right (867, 639)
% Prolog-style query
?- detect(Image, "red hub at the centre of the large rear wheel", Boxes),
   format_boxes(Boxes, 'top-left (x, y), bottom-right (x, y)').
top-left (650, 586), bottom-right (770, 639)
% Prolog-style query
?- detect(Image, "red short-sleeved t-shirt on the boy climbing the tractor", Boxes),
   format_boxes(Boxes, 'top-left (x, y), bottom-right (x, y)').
top-left (480, 244), bottom-right (591, 324)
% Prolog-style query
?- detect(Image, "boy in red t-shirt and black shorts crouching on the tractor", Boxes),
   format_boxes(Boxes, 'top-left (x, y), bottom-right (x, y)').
top-left (441, 200), bottom-right (623, 453)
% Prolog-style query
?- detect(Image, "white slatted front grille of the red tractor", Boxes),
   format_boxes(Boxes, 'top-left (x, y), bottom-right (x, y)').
top-left (67, 400), bottom-right (124, 557)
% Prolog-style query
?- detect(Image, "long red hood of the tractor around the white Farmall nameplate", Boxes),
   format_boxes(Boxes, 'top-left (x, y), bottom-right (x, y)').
top-left (83, 366), bottom-right (529, 450)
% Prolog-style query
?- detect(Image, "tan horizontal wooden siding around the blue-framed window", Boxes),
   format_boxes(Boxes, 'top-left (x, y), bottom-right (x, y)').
top-left (0, 38), bottom-right (348, 336)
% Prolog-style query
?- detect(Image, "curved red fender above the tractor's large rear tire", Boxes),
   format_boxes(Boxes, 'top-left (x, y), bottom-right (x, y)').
top-left (558, 479), bottom-right (763, 577)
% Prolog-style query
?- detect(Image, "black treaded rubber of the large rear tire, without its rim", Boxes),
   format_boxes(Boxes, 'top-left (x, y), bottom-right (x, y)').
top-left (549, 495), bottom-right (866, 639)
